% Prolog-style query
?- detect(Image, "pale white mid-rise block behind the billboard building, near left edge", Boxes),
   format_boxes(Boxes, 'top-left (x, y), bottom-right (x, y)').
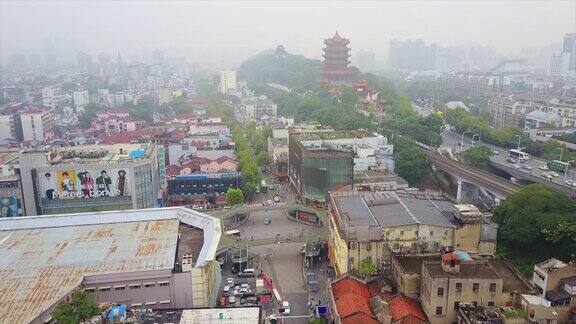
top-left (20, 108), bottom-right (53, 143)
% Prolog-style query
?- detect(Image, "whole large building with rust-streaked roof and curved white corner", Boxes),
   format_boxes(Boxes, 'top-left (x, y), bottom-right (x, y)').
top-left (0, 207), bottom-right (222, 323)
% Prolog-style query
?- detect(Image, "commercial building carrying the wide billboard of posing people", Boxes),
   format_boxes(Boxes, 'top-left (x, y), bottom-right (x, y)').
top-left (19, 144), bottom-right (160, 215)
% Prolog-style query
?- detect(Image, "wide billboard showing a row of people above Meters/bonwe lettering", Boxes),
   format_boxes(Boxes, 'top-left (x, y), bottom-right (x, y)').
top-left (39, 169), bottom-right (130, 200)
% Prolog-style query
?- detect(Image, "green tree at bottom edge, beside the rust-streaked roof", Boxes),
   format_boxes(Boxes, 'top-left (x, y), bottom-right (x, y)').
top-left (52, 290), bottom-right (99, 324)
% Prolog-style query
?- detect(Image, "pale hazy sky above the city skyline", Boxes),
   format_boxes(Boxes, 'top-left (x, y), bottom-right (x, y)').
top-left (0, 0), bottom-right (576, 66)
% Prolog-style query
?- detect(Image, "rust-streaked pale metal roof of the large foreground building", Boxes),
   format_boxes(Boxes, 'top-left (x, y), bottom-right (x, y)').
top-left (0, 218), bottom-right (180, 323)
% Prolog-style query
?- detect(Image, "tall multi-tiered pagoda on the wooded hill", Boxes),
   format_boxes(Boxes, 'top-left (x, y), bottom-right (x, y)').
top-left (322, 32), bottom-right (352, 83)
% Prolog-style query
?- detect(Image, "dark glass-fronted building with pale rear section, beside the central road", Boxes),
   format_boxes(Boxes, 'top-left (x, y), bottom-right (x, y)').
top-left (288, 130), bottom-right (394, 203)
